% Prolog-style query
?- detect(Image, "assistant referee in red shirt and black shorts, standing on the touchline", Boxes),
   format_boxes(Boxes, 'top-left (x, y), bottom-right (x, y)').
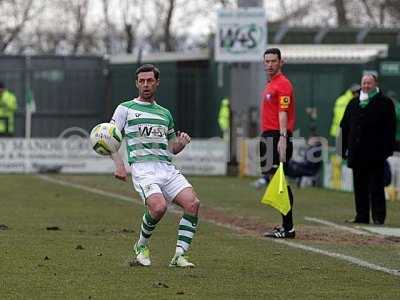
top-left (260, 48), bottom-right (296, 238)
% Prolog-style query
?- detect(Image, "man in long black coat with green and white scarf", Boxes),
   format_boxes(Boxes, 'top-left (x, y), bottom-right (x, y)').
top-left (340, 74), bottom-right (396, 225)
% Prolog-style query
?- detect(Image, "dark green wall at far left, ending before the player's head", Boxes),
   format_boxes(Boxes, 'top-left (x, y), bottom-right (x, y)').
top-left (0, 56), bottom-right (107, 137)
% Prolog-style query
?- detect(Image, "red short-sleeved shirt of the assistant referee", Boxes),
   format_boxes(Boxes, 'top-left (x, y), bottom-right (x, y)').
top-left (260, 73), bottom-right (296, 132)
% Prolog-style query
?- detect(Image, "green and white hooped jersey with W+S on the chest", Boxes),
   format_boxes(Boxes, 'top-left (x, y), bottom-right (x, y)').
top-left (111, 99), bottom-right (175, 164)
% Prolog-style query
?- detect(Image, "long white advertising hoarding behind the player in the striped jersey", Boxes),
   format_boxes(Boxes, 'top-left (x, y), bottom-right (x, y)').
top-left (0, 136), bottom-right (227, 175)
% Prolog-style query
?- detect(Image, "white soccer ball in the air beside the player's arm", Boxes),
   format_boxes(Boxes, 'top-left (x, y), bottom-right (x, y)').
top-left (90, 123), bottom-right (122, 155)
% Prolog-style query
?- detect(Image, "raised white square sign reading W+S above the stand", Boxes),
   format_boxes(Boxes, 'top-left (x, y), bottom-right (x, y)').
top-left (215, 7), bottom-right (267, 62)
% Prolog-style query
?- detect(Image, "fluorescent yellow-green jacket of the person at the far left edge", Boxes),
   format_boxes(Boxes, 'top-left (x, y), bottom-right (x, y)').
top-left (0, 90), bottom-right (17, 134)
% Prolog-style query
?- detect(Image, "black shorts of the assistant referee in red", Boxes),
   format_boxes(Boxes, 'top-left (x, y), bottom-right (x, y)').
top-left (260, 130), bottom-right (293, 175)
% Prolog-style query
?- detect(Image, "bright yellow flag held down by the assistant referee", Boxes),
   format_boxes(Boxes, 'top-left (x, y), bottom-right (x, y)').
top-left (261, 163), bottom-right (290, 215)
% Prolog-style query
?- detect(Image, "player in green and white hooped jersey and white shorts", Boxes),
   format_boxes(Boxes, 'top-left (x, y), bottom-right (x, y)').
top-left (111, 64), bottom-right (200, 267)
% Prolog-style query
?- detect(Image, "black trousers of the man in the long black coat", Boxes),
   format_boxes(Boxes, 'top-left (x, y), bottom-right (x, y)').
top-left (353, 161), bottom-right (386, 224)
